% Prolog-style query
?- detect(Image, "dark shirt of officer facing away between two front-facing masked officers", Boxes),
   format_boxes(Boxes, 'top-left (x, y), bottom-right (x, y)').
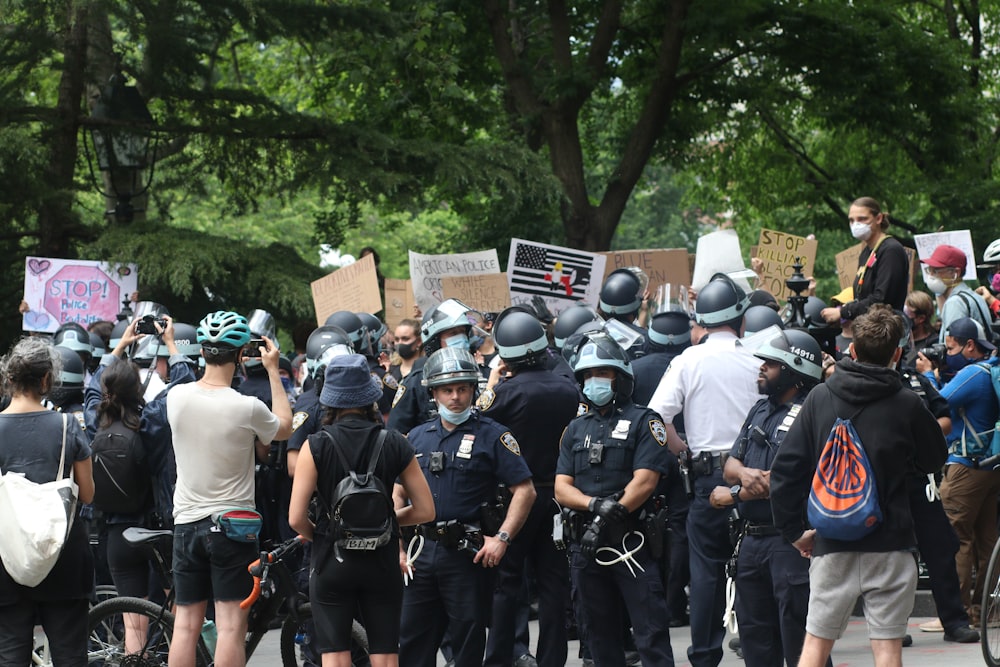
top-left (477, 368), bottom-right (580, 486)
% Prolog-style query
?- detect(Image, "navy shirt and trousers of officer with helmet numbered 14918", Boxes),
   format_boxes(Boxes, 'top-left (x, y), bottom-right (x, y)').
top-left (729, 391), bottom-right (809, 667)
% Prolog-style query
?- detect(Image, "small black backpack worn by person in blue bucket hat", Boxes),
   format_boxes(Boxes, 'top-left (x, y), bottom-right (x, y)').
top-left (323, 429), bottom-right (396, 559)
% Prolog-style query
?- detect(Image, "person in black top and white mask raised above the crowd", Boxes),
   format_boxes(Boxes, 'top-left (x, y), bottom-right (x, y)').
top-left (820, 197), bottom-right (910, 324)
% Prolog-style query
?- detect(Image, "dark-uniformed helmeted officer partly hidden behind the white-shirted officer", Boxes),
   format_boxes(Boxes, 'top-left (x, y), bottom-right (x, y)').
top-left (632, 309), bottom-right (691, 628)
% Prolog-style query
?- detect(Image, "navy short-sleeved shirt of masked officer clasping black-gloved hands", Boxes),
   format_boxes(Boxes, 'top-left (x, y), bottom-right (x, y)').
top-left (556, 401), bottom-right (670, 496)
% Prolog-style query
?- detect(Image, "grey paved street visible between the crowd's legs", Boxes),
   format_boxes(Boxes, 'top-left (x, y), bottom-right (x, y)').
top-left (249, 617), bottom-right (984, 667)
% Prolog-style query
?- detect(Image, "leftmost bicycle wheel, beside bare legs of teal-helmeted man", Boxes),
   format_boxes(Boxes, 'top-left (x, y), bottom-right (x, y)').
top-left (87, 597), bottom-right (207, 667)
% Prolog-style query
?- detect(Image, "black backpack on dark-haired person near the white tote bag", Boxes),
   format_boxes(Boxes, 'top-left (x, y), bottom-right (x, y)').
top-left (90, 421), bottom-right (153, 514)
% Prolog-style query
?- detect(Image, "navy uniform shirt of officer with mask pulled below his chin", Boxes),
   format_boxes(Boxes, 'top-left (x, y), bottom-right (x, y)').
top-left (408, 411), bottom-right (531, 523)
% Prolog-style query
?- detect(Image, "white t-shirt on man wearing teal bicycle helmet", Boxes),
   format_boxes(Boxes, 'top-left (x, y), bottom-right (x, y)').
top-left (167, 383), bottom-right (280, 524)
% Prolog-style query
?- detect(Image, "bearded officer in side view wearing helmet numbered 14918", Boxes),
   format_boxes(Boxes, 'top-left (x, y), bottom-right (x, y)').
top-left (710, 330), bottom-right (830, 667)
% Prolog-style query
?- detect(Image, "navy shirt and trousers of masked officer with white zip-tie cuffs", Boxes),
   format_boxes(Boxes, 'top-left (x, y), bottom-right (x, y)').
top-left (556, 401), bottom-right (674, 667)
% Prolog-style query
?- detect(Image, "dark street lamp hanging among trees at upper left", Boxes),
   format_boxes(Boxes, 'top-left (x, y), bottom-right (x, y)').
top-left (84, 72), bottom-right (156, 223)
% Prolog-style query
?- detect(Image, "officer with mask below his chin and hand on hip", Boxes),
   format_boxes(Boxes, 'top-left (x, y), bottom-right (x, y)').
top-left (396, 347), bottom-right (535, 667)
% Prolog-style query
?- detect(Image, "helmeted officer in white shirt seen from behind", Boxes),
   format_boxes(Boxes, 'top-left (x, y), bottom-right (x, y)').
top-left (649, 273), bottom-right (760, 667)
